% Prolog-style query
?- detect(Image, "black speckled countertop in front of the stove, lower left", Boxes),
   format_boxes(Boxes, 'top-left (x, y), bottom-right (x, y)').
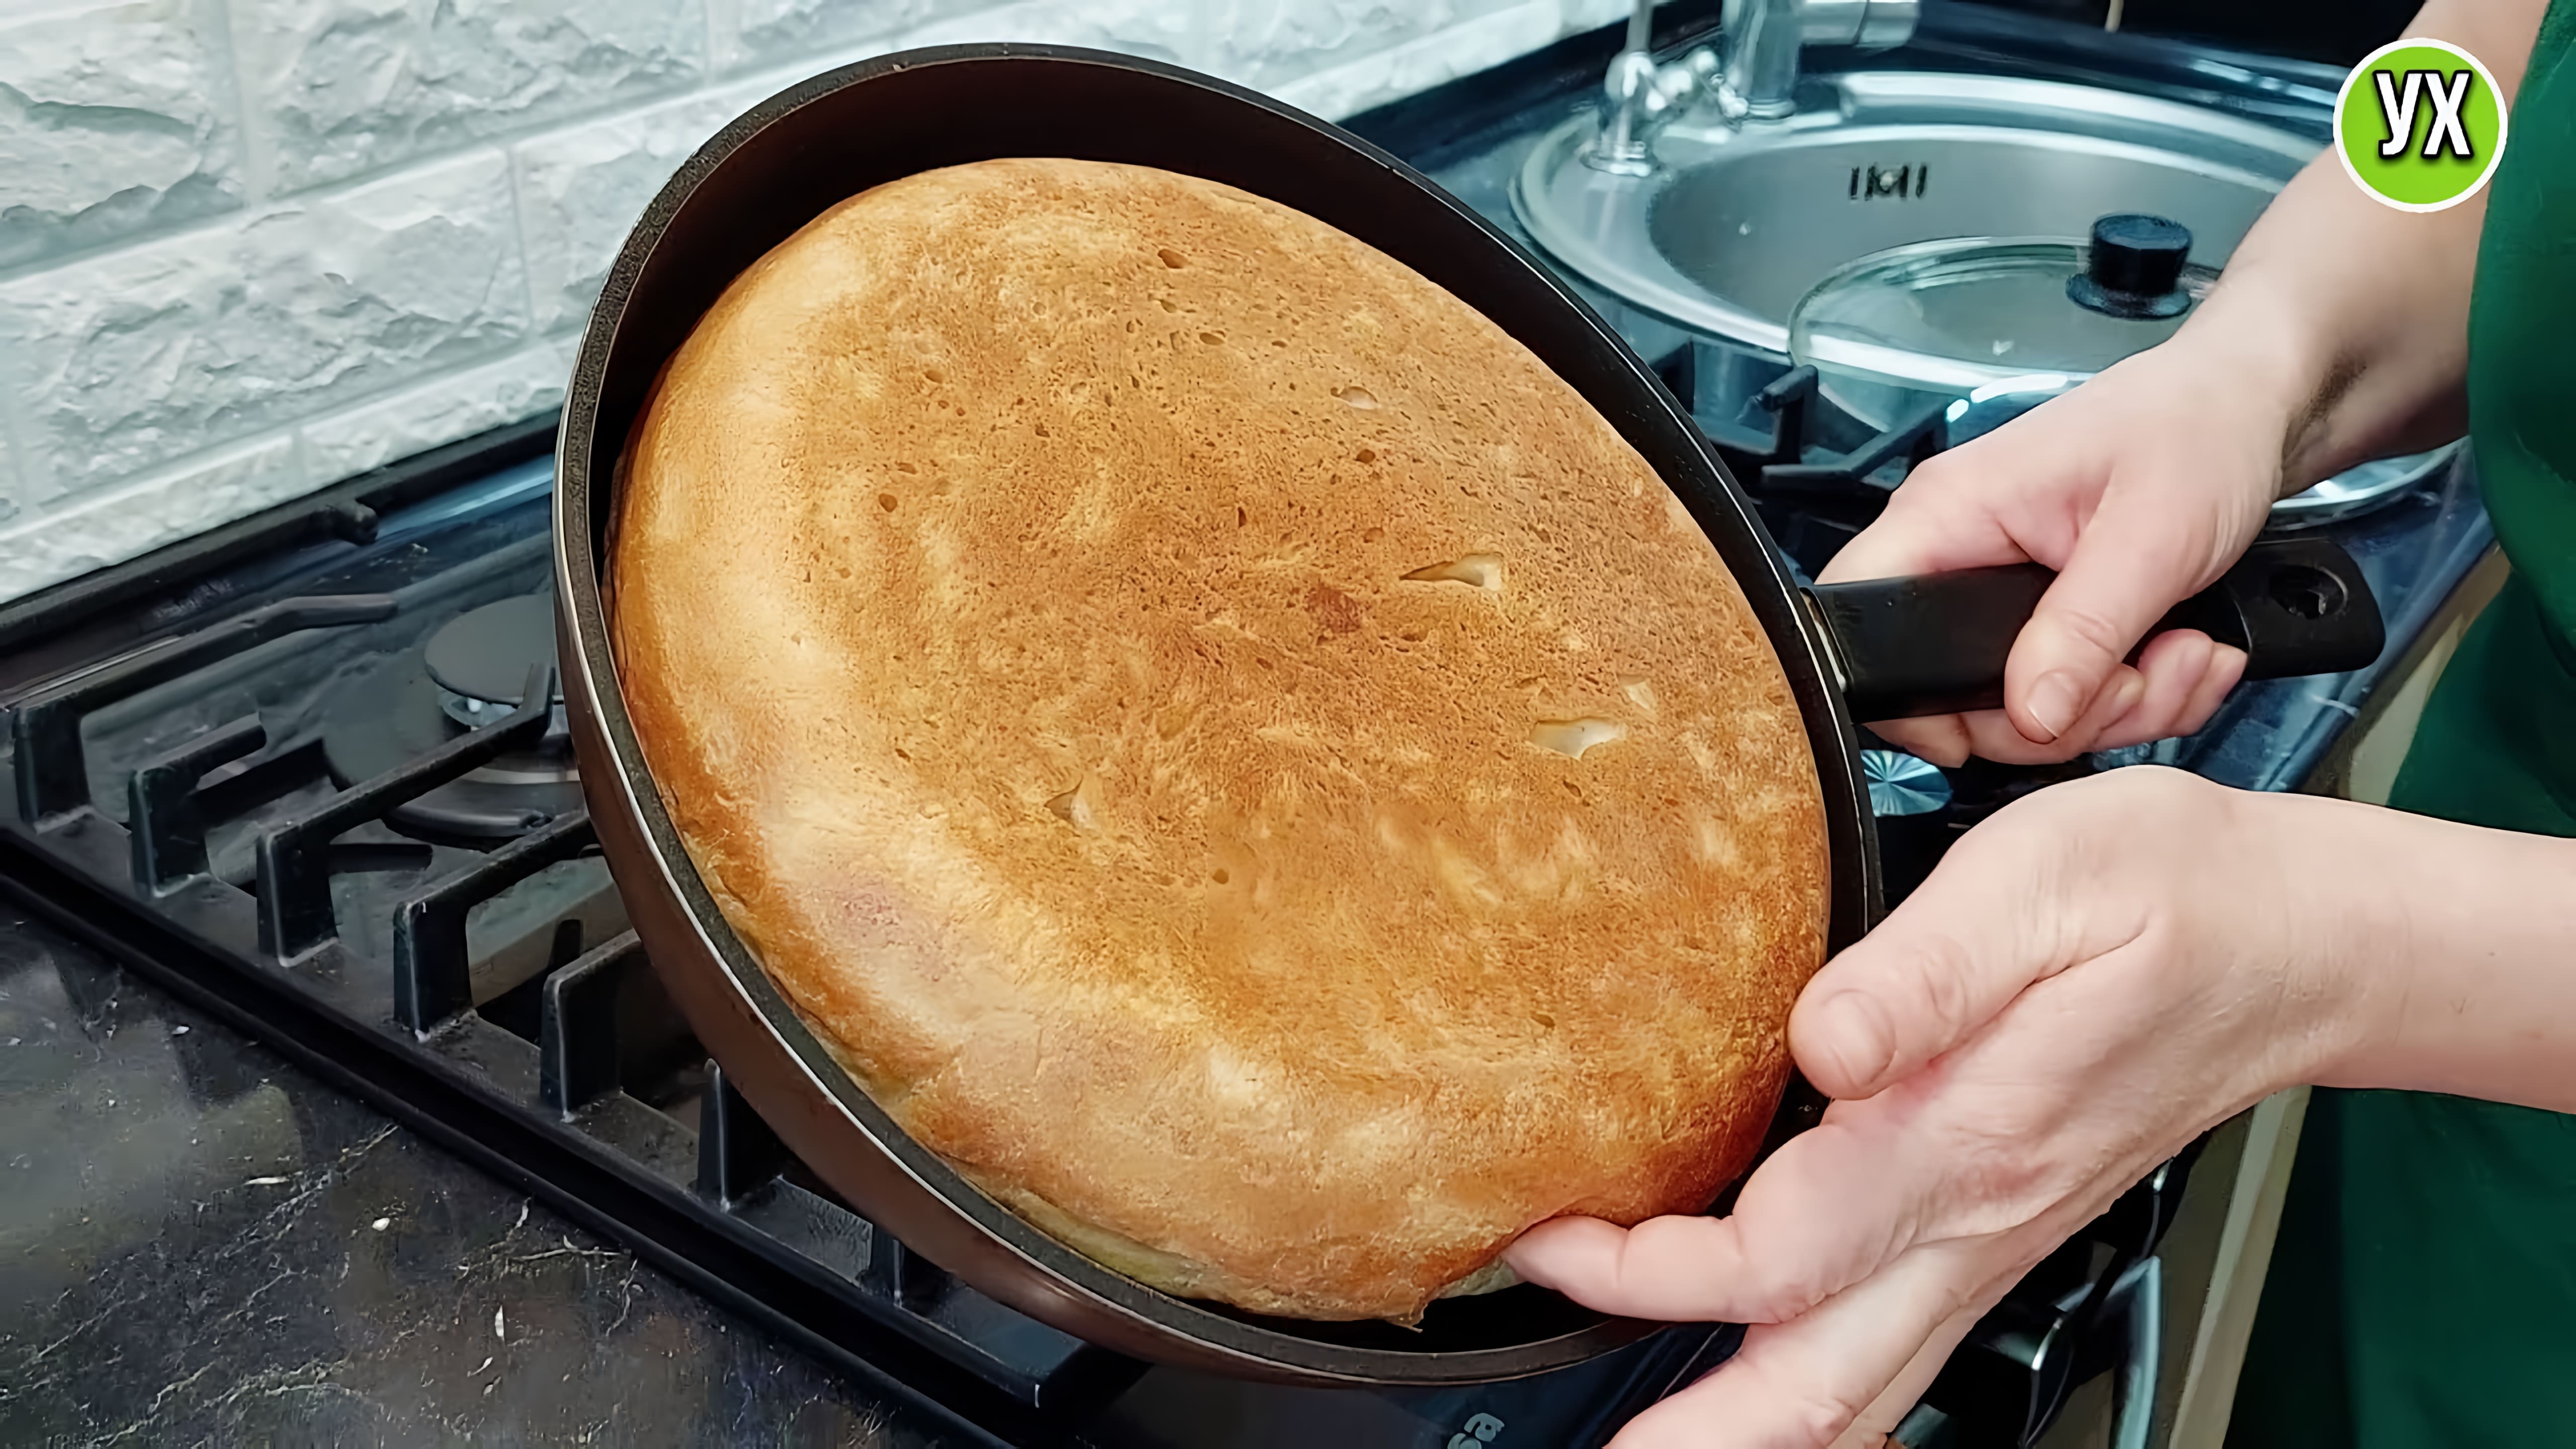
top-left (0, 908), bottom-right (966, 1449)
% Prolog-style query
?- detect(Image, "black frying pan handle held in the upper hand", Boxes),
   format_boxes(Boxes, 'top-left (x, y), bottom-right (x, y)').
top-left (1806, 539), bottom-right (2388, 722)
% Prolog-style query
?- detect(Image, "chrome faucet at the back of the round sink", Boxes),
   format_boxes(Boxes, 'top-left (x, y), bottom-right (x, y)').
top-left (1584, 0), bottom-right (1916, 175)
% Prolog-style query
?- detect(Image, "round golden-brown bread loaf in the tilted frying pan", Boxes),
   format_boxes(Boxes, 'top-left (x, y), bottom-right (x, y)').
top-left (610, 160), bottom-right (1826, 1323)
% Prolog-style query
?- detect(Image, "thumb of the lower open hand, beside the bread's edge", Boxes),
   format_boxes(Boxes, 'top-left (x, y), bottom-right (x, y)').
top-left (1788, 835), bottom-right (2063, 1101)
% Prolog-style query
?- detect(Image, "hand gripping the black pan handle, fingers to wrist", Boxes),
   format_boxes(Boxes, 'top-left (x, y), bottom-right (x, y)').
top-left (1819, 328), bottom-right (2300, 766)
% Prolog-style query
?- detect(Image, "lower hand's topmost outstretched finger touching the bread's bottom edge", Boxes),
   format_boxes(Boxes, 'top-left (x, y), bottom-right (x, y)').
top-left (1504, 1114), bottom-right (1940, 1323)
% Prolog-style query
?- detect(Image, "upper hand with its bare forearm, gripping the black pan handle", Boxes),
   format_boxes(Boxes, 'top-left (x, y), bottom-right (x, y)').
top-left (1819, 0), bottom-right (2548, 766)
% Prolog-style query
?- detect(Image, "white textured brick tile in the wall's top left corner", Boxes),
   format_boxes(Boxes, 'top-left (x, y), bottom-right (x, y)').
top-left (0, 0), bottom-right (242, 268)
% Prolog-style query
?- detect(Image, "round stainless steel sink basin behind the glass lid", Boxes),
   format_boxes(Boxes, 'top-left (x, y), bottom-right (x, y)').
top-left (1512, 69), bottom-right (2318, 353)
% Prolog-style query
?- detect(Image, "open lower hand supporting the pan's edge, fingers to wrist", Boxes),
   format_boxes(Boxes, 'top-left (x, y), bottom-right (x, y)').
top-left (1509, 768), bottom-right (2403, 1449)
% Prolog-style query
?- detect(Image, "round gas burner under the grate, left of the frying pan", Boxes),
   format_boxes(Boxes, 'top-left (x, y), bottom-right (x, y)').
top-left (322, 593), bottom-right (582, 846)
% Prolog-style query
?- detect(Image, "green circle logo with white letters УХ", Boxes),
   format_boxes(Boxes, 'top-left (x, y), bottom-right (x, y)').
top-left (2334, 39), bottom-right (2504, 211)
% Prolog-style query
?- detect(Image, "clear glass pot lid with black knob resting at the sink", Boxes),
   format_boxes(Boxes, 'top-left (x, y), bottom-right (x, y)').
top-left (1788, 216), bottom-right (2218, 397)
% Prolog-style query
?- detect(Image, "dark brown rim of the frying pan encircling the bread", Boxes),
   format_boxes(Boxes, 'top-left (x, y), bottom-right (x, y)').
top-left (554, 44), bottom-right (1875, 1385)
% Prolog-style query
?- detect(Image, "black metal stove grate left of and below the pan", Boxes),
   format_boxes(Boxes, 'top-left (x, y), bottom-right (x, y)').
top-left (0, 420), bottom-right (1144, 1444)
